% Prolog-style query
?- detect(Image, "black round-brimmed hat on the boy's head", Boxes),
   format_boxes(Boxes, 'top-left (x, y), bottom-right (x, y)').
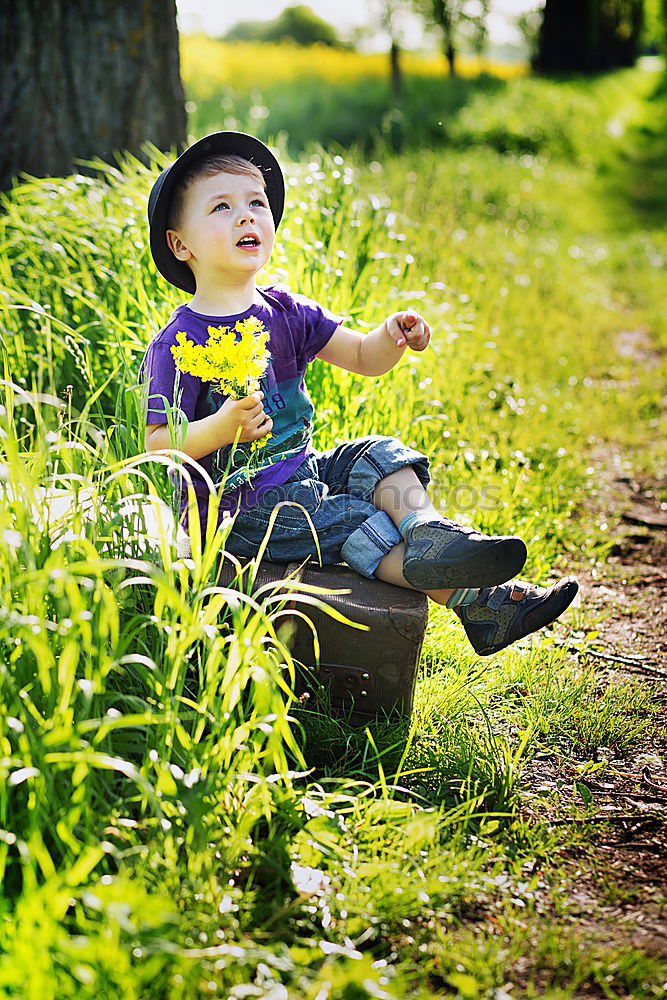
top-left (148, 132), bottom-right (285, 294)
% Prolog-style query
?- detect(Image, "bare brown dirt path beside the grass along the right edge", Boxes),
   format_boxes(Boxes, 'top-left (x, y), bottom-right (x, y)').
top-left (523, 420), bottom-right (667, 976)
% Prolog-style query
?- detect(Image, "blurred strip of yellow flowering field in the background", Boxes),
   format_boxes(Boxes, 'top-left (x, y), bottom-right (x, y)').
top-left (181, 35), bottom-right (527, 99)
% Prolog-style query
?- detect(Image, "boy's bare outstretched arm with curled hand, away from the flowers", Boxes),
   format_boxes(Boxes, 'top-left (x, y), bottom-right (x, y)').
top-left (317, 309), bottom-right (431, 376)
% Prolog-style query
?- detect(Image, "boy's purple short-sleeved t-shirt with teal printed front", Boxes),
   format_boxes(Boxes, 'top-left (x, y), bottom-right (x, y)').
top-left (139, 287), bottom-right (341, 526)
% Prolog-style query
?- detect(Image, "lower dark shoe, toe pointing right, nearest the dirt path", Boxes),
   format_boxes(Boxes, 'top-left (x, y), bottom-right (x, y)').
top-left (454, 576), bottom-right (579, 656)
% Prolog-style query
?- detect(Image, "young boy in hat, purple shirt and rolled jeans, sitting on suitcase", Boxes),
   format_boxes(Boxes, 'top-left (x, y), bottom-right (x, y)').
top-left (141, 132), bottom-right (578, 656)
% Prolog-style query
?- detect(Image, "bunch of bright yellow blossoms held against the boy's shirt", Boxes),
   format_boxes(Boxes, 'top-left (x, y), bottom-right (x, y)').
top-left (171, 316), bottom-right (269, 399)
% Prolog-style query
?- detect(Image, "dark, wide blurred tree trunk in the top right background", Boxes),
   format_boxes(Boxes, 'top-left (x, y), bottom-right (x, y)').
top-left (535, 0), bottom-right (644, 73)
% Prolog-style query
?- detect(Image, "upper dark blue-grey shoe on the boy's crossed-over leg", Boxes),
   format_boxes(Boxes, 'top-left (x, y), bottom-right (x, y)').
top-left (403, 518), bottom-right (527, 590)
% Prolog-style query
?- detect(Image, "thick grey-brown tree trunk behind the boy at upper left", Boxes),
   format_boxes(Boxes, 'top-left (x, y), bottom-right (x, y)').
top-left (0, 0), bottom-right (186, 189)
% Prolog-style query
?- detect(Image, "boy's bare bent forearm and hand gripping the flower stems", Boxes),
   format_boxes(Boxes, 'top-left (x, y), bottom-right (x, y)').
top-left (144, 392), bottom-right (273, 462)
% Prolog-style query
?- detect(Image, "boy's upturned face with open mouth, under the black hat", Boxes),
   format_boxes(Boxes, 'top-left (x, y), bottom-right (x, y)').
top-left (167, 172), bottom-right (276, 290)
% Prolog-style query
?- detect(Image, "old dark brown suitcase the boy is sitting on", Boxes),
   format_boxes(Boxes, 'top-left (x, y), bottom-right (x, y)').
top-left (220, 561), bottom-right (428, 725)
